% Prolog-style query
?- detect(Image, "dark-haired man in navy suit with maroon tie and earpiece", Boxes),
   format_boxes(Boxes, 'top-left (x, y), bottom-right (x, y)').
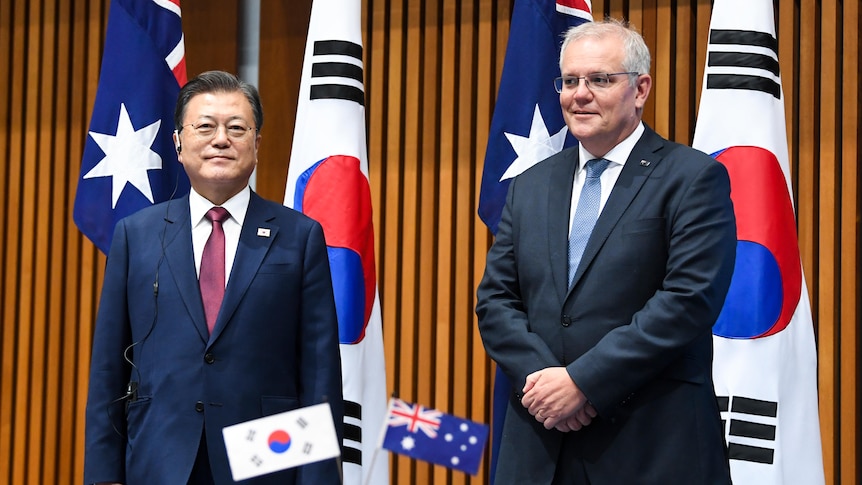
top-left (84, 71), bottom-right (343, 485)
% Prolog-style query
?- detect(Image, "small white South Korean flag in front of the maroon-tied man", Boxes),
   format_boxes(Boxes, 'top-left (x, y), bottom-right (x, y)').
top-left (222, 403), bottom-right (341, 481)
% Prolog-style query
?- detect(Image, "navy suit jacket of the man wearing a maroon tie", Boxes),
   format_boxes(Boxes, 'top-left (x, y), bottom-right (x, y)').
top-left (84, 193), bottom-right (343, 485)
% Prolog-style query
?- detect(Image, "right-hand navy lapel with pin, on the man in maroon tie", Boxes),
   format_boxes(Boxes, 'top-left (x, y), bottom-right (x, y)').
top-left (210, 192), bottom-right (278, 342)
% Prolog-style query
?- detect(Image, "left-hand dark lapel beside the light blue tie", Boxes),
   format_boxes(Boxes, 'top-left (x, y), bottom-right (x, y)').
top-left (545, 149), bottom-right (578, 301)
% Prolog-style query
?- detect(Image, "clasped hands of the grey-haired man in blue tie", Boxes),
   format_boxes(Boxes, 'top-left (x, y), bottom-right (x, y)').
top-left (521, 367), bottom-right (598, 432)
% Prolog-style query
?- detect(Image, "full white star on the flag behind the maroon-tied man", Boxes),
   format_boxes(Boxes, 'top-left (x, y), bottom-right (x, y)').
top-left (84, 104), bottom-right (162, 209)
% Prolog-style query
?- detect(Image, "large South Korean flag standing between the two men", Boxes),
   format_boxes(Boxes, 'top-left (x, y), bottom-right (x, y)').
top-left (284, 0), bottom-right (389, 485)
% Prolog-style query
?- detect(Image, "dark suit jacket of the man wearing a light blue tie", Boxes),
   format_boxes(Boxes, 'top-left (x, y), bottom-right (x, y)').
top-left (476, 127), bottom-right (736, 485)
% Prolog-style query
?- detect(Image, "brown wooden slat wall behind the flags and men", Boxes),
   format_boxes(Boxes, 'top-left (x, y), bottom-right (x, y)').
top-left (0, 0), bottom-right (862, 484)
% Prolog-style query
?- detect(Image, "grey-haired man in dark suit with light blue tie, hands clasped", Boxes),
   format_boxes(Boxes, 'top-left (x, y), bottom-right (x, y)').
top-left (476, 20), bottom-right (736, 485)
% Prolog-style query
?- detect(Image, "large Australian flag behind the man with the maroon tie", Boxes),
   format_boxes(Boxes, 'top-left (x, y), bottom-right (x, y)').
top-left (74, 0), bottom-right (189, 254)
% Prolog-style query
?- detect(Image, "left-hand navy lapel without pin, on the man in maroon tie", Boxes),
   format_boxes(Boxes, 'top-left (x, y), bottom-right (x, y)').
top-left (164, 195), bottom-right (209, 341)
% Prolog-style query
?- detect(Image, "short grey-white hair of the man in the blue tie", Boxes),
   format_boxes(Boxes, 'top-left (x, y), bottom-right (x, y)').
top-left (560, 18), bottom-right (650, 85)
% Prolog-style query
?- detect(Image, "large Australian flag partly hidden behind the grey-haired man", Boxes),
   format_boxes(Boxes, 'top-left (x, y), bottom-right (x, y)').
top-left (479, 0), bottom-right (593, 484)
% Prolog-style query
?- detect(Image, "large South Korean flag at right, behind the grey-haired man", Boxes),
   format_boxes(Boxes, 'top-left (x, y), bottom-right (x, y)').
top-left (693, 0), bottom-right (824, 485)
